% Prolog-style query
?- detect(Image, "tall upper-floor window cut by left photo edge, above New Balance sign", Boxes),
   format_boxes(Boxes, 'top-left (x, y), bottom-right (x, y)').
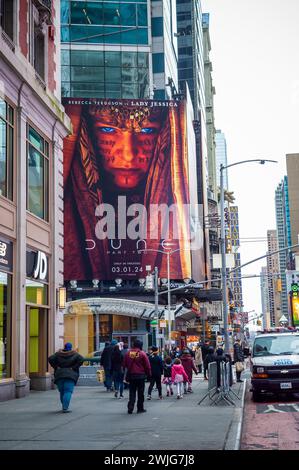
top-left (0, 98), bottom-right (14, 200)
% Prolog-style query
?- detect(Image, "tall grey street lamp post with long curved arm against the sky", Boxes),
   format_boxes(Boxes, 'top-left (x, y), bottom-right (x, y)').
top-left (220, 159), bottom-right (277, 353)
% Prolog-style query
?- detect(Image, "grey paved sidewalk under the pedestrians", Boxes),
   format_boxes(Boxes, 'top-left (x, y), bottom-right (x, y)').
top-left (0, 376), bottom-right (245, 450)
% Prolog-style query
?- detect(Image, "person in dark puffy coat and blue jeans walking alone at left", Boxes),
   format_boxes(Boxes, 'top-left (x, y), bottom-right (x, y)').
top-left (48, 343), bottom-right (84, 413)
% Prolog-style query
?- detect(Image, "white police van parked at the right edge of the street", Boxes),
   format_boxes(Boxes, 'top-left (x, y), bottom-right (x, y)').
top-left (250, 330), bottom-right (299, 401)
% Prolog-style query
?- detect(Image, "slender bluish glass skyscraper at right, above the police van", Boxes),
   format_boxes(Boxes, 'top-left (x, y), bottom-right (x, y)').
top-left (275, 176), bottom-right (291, 318)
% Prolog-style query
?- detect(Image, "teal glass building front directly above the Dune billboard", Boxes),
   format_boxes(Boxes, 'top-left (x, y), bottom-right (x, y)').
top-left (61, 0), bottom-right (151, 99)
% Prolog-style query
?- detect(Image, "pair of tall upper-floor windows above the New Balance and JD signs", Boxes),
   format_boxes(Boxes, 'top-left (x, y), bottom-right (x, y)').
top-left (0, 99), bottom-right (49, 221)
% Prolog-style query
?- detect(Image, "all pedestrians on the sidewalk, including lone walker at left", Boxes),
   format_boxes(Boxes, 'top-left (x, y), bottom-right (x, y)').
top-left (48, 339), bottom-right (244, 414)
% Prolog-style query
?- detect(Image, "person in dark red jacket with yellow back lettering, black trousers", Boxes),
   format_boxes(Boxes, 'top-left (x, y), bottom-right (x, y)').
top-left (124, 339), bottom-right (151, 414)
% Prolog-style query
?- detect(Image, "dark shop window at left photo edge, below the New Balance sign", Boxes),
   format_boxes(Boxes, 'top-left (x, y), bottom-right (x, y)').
top-left (0, 272), bottom-right (12, 380)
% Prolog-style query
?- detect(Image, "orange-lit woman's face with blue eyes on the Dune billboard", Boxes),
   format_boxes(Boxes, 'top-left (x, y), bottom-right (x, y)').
top-left (94, 120), bottom-right (161, 190)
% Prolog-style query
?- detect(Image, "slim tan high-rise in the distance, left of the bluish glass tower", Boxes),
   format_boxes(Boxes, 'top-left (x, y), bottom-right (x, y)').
top-left (267, 230), bottom-right (281, 326)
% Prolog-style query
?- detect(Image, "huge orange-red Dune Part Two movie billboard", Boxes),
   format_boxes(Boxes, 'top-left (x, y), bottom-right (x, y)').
top-left (63, 98), bottom-right (202, 281)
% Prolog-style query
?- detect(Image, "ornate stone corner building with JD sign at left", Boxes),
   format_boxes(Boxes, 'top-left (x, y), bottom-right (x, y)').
top-left (0, 0), bottom-right (70, 400)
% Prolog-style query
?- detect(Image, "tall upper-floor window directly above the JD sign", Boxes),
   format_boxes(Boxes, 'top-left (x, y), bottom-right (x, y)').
top-left (27, 126), bottom-right (49, 221)
